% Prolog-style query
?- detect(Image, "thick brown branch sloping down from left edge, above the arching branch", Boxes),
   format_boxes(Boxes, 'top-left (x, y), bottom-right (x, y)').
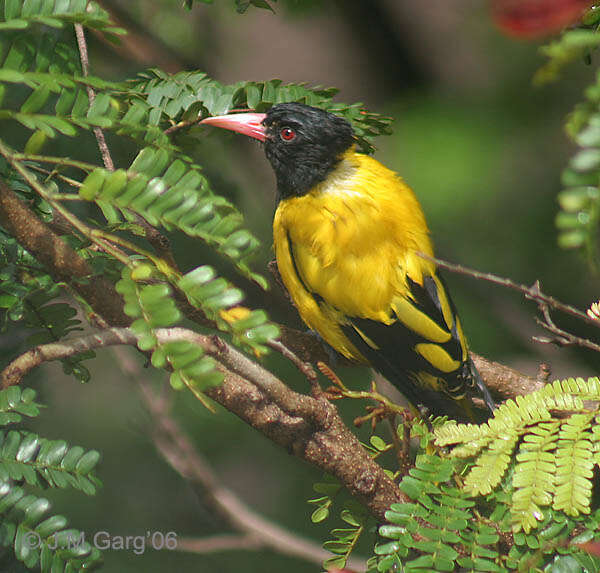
top-left (0, 179), bottom-right (131, 326)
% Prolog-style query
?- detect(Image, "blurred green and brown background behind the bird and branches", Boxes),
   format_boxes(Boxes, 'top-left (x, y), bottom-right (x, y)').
top-left (3, 0), bottom-right (600, 573)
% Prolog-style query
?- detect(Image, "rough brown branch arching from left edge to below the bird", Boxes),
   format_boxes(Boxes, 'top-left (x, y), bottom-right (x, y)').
top-left (0, 328), bottom-right (408, 520)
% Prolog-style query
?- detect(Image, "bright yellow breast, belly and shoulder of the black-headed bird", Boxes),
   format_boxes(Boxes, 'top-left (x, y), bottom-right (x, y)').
top-left (273, 150), bottom-right (433, 360)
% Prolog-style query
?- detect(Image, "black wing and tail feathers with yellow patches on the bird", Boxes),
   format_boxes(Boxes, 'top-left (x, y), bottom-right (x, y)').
top-left (342, 276), bottom-right (494, 421)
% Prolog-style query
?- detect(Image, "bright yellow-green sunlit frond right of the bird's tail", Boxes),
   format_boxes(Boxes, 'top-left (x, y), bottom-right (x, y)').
top-left (435, 378), bottom-right (600, 533)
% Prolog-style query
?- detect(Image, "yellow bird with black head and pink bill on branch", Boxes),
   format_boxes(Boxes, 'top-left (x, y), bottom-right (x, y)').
top-left (201, 102), bottom-right (494, 422)
